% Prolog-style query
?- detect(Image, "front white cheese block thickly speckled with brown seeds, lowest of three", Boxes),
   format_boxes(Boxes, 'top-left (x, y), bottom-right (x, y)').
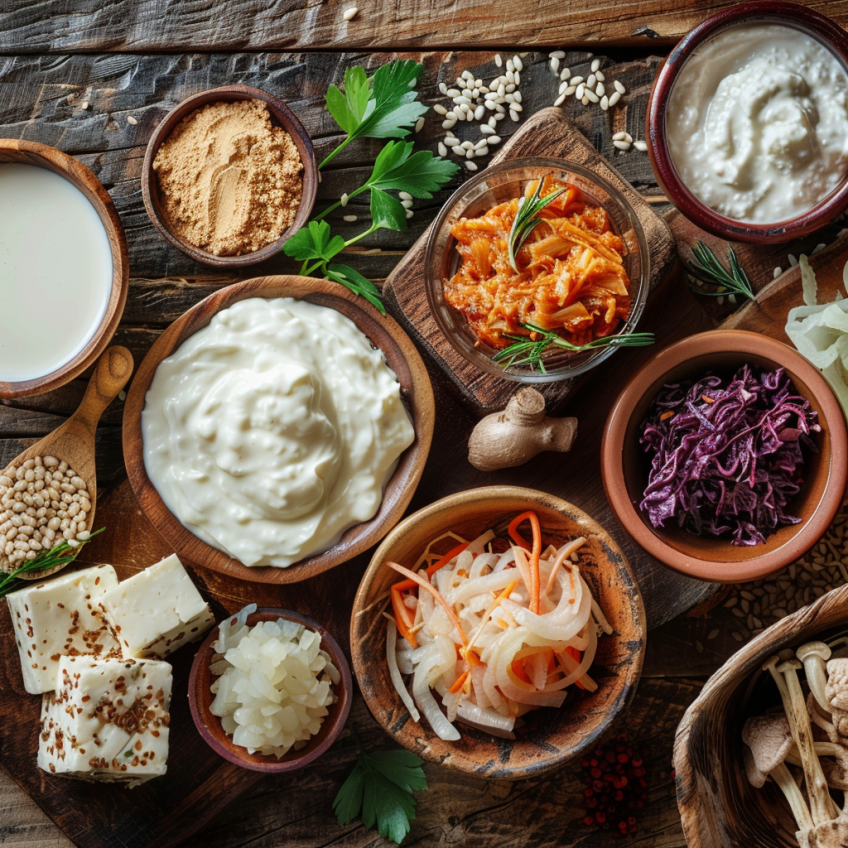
top-left (38, 657), bottom-right (172, 786)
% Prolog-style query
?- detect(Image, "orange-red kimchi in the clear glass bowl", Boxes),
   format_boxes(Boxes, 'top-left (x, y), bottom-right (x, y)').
top-left (443, 176), bottom-right (630, 348)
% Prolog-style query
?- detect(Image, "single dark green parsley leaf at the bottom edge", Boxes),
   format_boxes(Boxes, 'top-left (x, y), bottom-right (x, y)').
top-left (333, 734), bottom-right (427, 845)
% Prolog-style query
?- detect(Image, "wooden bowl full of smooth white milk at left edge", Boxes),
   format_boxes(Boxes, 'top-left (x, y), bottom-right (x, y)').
top-left (0, 139), bottom-right (129, 398)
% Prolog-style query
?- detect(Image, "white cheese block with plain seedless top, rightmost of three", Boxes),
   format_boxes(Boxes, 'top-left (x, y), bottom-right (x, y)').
top-left (100, 554), bottom-right (215, 659)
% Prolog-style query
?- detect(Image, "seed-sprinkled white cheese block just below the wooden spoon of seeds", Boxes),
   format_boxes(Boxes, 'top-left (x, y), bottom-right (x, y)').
top-left (6, 565), bottom-right (122, 695)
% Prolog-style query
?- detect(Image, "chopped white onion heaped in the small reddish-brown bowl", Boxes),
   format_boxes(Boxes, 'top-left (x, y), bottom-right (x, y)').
top-left (209, 604), bottom-right (340, 759)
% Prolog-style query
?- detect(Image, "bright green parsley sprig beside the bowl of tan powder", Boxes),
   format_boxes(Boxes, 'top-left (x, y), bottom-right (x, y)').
top-left (283, 59), bottom-right (459, 314)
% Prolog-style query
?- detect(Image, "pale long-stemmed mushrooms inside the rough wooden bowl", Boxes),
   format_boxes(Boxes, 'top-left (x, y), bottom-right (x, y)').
top-left (742, 642), bottom-right (848, 848)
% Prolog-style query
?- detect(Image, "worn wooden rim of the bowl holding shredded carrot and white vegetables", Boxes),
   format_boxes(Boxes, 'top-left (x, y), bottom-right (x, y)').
top-left (350, 486), bottom-right (647, 780)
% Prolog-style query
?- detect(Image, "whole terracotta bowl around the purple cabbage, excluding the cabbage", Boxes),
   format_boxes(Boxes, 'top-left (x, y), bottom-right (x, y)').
top-left (601, 330), bottom-right (848, 583)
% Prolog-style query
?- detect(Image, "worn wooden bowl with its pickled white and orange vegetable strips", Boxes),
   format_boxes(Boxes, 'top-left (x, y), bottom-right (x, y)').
top-left (350, 486), bottom-right (646, 780)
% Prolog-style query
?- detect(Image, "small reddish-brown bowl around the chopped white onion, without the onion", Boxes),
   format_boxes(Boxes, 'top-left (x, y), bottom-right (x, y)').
top-left (188, 607), bottom-right (353, 774)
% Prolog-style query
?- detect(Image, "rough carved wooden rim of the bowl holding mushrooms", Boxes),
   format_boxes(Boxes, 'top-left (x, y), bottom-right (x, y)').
top-left (672, 586), bottom-right (848, 848)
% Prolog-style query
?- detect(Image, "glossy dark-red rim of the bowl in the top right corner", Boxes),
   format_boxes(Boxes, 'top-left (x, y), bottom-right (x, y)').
top-left (645, 0), bottom-right (848, 244)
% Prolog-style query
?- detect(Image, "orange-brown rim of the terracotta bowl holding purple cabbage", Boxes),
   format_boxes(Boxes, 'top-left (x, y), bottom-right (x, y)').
top-left (601, 330), bottom-right (848, 583)
